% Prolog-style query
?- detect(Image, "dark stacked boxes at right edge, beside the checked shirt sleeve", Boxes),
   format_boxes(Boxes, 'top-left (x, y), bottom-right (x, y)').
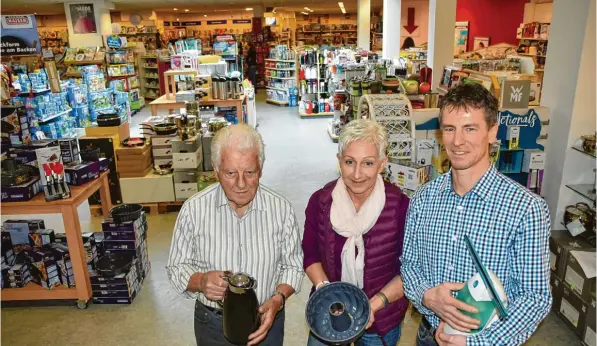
top-left (549, 231), bottom-right (596, 345)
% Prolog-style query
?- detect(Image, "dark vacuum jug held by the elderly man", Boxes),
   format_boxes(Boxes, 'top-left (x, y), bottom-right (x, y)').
top-left (218, 272), bottom-right (261, 345)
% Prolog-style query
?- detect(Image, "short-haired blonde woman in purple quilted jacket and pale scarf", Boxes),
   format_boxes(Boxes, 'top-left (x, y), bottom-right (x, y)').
top-left (302, 119), bottom-right (409, 346)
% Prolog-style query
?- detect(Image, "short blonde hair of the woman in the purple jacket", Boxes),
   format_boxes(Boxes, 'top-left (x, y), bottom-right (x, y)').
top-left (338, 119), bottom-right (388, 159)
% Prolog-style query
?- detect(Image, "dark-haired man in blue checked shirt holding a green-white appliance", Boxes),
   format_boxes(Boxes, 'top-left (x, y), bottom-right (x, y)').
top-left (401, 84), bottom-right (552, 346)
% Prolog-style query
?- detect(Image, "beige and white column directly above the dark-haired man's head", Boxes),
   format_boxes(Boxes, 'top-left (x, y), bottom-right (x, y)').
top-left (424, 0), bottom-right (456, 90)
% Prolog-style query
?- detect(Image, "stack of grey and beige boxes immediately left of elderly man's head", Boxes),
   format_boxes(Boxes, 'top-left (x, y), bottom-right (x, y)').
top-left (172, 135), bottom-right (203, 201)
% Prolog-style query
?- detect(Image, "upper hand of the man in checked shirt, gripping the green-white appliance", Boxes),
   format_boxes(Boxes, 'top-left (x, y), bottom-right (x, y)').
top-left (423, 282), bottom-right (480, 333)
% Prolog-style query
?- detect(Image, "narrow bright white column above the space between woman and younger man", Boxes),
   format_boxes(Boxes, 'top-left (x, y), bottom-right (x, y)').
top-left (382, 0), bottom-right (402, 59)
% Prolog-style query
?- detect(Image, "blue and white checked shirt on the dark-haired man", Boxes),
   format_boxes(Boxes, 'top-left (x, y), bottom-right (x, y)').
top-left (400, 165), bottom-right (552, 345)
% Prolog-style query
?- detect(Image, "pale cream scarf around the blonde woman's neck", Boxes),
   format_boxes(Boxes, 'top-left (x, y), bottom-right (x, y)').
top-left (330, 174), bottom-right (386, 288)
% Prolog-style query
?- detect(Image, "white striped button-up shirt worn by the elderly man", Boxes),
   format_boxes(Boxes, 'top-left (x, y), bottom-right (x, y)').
top-left (166, 184), bottom-right (304, 308)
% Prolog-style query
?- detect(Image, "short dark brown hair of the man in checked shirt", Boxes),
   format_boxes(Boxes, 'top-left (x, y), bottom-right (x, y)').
top-left (439, 83), bottom-right (498, 128)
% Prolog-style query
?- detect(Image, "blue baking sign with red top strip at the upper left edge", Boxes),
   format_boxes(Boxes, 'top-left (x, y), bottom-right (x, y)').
top-left (0, 15), bottom-right (41, 56)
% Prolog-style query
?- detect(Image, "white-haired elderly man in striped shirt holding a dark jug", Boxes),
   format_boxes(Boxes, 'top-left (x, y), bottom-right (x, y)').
top-left (166, 125), bottom-right (304, 346)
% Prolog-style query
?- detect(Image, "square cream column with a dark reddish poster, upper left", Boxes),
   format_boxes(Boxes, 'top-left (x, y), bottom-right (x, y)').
top-left (64, 0), bottom-right (114, 48)
